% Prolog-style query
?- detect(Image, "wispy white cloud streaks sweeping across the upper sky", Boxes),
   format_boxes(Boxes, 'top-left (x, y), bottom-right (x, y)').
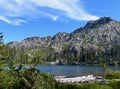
top-left (0, 0), bottom-right (98, 25)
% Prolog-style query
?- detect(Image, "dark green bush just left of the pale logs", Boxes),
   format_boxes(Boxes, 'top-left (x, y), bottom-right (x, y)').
top-left (15, 68), bottom-right (55, 89)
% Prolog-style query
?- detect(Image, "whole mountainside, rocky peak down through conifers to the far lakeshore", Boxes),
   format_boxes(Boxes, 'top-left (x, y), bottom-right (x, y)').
top-left (8, 17), bottom-right (120, 64)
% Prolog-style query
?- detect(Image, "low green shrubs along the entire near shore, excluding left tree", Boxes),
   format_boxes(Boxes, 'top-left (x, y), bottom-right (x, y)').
top-left (0, 65), bottom-right (120, 89)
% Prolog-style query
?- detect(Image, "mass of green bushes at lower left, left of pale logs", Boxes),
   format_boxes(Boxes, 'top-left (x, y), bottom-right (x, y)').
top-left (0, 66), bottom-right (55, 89)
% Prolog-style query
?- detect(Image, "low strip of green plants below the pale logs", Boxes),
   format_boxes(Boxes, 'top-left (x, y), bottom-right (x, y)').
top-left (56, 82), bottom-right (120, 89)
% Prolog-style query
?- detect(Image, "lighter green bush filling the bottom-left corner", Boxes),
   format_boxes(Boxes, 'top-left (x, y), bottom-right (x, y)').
top-left (0, 70), bottom-right (19, 89)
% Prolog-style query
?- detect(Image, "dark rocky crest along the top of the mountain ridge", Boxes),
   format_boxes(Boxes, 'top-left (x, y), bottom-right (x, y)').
top-left (8, 17), bottom-right (118, 44)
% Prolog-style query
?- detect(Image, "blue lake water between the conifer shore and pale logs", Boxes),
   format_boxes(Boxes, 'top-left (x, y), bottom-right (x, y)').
top-left (37, 65), bottom-right (120, 77)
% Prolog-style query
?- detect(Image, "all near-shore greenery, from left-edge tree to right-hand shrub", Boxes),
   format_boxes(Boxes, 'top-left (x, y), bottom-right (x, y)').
top-left (0, 33), bottom-right (120, 89)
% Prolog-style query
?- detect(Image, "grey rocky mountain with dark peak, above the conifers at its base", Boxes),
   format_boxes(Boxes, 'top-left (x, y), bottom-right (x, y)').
top-left (8, 17), bottom-right (120, 64)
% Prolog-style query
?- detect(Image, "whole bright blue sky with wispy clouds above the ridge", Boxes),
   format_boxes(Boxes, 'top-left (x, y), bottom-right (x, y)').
top-left (0, 0), bottom-right (120, 43)
